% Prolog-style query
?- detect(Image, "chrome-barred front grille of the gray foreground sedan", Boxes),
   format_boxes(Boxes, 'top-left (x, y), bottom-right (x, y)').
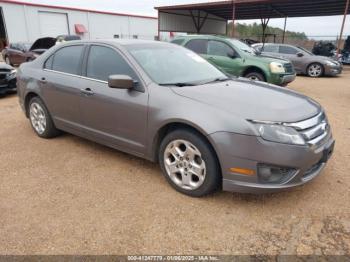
top-left (286, 112), bottom-right (330, 146)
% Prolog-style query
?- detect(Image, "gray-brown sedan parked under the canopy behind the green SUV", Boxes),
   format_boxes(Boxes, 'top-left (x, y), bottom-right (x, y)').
top-left (253, 43), bottom-right (343, 77)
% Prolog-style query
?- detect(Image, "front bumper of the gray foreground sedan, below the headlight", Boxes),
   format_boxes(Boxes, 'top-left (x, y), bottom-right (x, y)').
top-left (210, 132), bottom-right (334, 194)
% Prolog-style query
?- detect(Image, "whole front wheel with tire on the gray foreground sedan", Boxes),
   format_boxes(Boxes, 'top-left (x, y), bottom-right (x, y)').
top-left (159, 129), bottom-right (221, 197)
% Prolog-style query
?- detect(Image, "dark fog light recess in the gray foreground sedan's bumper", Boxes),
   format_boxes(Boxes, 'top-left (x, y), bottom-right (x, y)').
top-left (258, 164), bottom-right (296, 183)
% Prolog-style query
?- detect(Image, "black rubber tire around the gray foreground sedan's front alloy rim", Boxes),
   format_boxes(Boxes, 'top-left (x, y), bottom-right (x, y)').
top-left (158, 128), bottom-right (222, 197)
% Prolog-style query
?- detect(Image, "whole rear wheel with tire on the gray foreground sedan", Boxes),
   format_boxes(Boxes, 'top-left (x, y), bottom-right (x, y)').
top-left (28, 97), bottom-right (60, 138)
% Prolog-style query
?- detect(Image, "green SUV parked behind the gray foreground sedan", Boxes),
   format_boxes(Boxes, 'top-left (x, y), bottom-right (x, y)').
top-left (172, 35), bottom-right (295, 86)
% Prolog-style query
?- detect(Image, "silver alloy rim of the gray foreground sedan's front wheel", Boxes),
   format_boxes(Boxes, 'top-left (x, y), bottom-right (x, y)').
top-left (164, 140), bottom-right (206, 190)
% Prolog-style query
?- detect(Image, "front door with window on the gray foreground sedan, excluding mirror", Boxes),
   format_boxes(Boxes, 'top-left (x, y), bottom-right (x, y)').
top-left (81, 45), bottom-right (148, 154)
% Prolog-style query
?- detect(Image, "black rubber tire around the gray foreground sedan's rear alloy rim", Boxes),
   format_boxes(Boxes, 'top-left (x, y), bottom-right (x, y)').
top-left (28, 96), bottom-right (61, 138)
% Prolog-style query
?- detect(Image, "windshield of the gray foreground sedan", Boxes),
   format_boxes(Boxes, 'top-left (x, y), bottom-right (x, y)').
top-left (127, 44), bottom-right (227, 86)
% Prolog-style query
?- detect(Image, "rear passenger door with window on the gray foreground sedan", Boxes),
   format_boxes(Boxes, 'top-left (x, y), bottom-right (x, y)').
top-left (39, 45), bottom-right (85, 130)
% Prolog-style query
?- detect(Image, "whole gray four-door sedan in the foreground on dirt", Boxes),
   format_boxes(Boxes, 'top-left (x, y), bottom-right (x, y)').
top-left (18, 40), bottom-right (334, 196)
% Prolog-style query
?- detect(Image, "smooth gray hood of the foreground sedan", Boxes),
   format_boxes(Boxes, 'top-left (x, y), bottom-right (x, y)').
top-left (172, 79), bottom-right (321, 122)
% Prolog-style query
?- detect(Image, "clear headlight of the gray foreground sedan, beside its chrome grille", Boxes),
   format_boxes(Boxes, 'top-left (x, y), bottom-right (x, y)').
top-left (255, 123), bottom-right (305, 145)
